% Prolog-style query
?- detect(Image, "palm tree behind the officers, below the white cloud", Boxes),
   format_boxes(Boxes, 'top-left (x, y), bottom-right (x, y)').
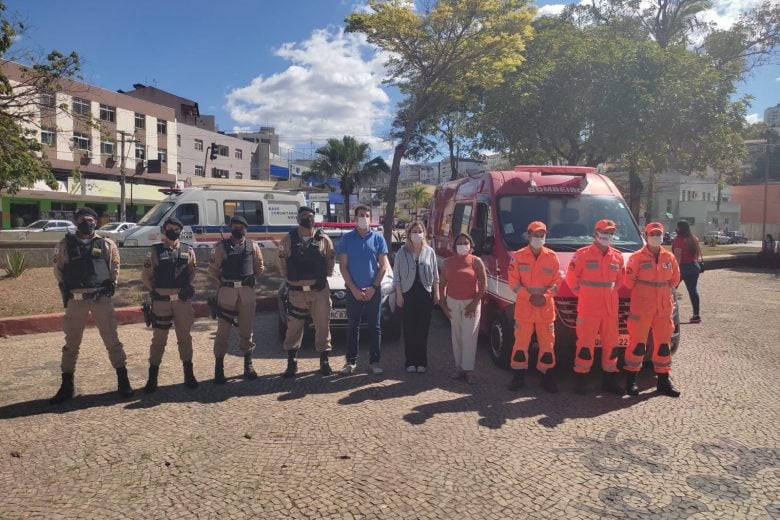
top-left (305, 135), bottom-right (390, 221)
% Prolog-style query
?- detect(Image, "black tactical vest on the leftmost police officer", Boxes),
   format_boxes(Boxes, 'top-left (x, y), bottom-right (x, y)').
top-left (65, 235), bottom-right (111, 291)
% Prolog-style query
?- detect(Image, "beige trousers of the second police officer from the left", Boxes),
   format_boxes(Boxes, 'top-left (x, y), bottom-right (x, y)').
top-left (149, 289), bottom-right (195, 366)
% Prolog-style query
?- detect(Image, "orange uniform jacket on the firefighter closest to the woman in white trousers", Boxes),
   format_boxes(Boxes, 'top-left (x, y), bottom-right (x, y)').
top-left (508, 246), bottom-right (563, 322)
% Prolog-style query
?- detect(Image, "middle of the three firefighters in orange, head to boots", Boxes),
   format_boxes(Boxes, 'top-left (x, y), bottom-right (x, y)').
top-left (566, 219), bottom-right (625, 395)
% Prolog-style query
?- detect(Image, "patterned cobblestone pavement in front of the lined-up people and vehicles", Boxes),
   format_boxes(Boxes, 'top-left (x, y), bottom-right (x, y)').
top-left (0, 270), bottom-right (780, 519)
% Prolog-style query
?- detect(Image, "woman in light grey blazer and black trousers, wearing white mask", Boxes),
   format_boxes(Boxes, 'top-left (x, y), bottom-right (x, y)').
top-left (393, 221), bottom-right (439, 373)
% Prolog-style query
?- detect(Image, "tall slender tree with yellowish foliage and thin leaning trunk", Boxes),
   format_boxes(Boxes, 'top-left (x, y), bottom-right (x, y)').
top-left (346, 0), bottom-right (534, 247)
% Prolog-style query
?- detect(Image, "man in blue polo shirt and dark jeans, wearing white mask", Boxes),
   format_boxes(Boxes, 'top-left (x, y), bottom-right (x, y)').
top-left (336, 206), bottom-right (387, 375)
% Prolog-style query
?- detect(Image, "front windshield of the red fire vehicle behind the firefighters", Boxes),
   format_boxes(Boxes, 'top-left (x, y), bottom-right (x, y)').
top-left (498, 195), bottom-right (644, 252)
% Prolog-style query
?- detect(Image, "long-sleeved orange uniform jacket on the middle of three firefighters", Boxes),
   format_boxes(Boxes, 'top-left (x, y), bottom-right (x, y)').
top-left (566, 243), bottom-right (625, 316)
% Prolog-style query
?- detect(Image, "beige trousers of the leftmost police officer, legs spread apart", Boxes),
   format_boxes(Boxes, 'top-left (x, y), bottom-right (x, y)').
top-left (62, 296), bottom-right (127, 373)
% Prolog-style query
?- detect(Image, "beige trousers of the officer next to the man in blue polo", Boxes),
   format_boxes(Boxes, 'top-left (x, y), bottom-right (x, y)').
top-left (284, 285), bottom-right (331, 352)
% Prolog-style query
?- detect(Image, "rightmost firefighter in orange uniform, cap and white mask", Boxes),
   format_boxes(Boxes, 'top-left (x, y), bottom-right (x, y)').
top-left (624, 222), bottom-right (680, 397)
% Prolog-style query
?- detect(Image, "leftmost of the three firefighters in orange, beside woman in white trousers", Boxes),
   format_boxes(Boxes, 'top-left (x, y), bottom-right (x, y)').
top-left (509, 222), bottom-right (562, 393)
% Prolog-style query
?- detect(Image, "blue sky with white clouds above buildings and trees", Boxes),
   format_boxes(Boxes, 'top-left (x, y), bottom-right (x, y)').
top-left (5, 0), bottom-right (780, 156)
